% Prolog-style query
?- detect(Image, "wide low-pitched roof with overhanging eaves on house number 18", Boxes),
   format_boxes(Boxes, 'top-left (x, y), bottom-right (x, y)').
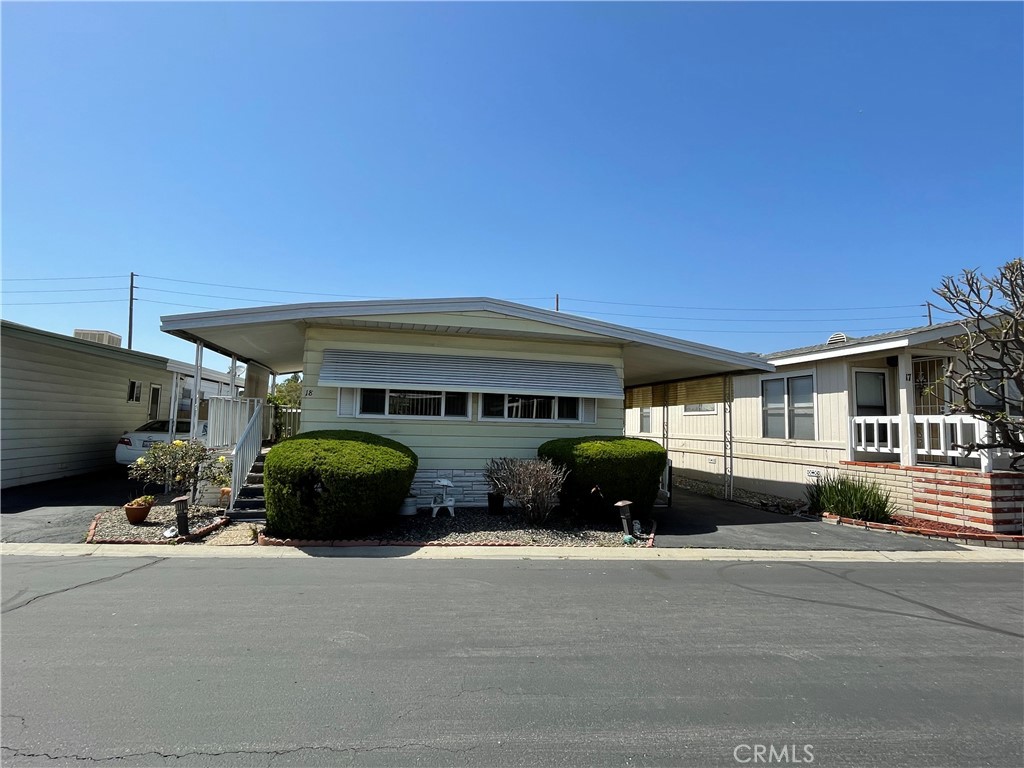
top-left (161, 298), bottom-right (774, 387)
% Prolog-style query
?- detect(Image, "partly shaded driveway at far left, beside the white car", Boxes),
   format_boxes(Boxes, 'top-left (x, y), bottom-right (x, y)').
top-left (0, 465), bottom-right (141, 544)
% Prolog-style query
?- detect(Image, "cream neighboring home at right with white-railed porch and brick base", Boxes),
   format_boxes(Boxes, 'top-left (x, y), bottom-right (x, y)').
top-left (626, 322), bottom-right (1024, 530)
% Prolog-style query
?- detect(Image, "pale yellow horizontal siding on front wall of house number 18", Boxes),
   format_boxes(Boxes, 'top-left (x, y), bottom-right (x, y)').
top-left (301, 325), bottom-right (624, 470)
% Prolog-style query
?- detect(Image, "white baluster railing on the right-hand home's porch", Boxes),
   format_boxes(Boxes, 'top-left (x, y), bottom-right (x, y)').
top-left (850, 414), bottom-right (1011, 471)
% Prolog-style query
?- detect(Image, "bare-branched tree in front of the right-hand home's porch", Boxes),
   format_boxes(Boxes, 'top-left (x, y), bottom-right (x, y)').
top-left (935, 259), bottom-right (1024, 469)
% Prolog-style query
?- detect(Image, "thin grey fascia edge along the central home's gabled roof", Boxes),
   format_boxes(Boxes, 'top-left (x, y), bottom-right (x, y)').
top-left (161, 297), bottom-right (772, 371)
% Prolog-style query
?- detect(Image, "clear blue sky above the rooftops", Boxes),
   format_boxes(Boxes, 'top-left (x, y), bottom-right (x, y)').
top-left (0, 2), bottom-right (1024, 370)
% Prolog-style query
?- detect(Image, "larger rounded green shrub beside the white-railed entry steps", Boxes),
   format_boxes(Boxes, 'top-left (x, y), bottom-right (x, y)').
top-left (263, 430), bottom-right (419, 539)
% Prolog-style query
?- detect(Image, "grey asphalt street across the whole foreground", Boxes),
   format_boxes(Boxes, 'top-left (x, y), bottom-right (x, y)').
top-left (0, 555), bottom-right (1024, 768)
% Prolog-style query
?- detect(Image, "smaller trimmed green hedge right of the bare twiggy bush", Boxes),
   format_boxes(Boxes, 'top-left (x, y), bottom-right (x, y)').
top-left (537, 436), bottom-right (668, 515)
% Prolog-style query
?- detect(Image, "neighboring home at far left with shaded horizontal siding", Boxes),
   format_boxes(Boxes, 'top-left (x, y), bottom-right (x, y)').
top-left (0, 321), bottom-right (237, 488)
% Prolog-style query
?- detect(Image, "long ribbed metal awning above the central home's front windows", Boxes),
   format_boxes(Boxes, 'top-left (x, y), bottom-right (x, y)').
top-left (317, 349), bottom-right (624, 400)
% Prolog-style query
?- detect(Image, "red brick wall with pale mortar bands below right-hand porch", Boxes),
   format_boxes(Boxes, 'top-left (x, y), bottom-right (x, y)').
top-left (840, 461), bottom-right (1024, 534)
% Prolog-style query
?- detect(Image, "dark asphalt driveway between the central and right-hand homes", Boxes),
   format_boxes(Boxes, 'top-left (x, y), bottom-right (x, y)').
top-left (654, 488), bottom-right (963, 552)
